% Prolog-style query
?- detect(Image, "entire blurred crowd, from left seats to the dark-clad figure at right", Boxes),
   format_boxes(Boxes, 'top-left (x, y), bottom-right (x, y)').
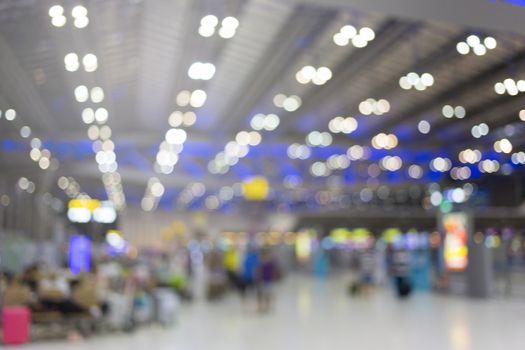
top-left (0, 232), bottom-right (430, 344)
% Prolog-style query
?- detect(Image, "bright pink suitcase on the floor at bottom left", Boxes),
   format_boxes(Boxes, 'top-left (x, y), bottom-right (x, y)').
top-left (2, 307), bottom-right (31, 344)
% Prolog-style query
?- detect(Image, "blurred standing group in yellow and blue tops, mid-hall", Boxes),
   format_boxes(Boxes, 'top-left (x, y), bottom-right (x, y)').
top-left (208, 244), bottom-right (281, 312)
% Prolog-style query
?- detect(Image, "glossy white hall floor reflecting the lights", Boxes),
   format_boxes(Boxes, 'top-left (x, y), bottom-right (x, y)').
top-left (9, 277), bottom-right (525, 350)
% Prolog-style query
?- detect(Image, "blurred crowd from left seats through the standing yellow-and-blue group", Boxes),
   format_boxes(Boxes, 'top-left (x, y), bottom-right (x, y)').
top-left (0, 244), bottom-right (282, 336)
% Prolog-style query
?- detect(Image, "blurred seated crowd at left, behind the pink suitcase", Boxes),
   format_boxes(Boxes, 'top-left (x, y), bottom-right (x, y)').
top-left (0, 261), bottom-right (178, 337)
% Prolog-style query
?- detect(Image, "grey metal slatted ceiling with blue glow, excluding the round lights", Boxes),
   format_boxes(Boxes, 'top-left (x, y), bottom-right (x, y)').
top-left (0, 0), bottom-right (525, 208)
